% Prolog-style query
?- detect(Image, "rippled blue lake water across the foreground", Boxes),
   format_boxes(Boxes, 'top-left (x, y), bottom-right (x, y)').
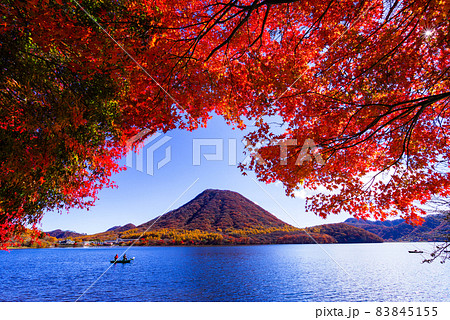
top-left (0, 243), bottom-right (450, 301)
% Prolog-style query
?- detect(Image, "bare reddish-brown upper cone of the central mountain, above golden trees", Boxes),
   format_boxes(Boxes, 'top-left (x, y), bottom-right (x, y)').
top-left (137, 189), bottom-right (289, 231)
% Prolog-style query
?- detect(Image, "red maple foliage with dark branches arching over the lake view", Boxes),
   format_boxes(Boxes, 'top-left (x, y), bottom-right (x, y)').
top-left (0, 0), bottom-right (450, 248)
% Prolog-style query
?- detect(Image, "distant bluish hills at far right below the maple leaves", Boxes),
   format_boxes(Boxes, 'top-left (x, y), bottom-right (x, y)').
top-left (344, 214), bottom-right (450, 241)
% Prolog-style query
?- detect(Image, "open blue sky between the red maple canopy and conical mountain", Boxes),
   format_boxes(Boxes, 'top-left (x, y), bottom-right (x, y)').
top-left (41, 117), bottom-right (350, 234)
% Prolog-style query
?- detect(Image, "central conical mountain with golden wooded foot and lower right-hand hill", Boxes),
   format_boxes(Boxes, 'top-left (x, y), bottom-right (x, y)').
top-left (59, 189), bottom-right (382, 245)
